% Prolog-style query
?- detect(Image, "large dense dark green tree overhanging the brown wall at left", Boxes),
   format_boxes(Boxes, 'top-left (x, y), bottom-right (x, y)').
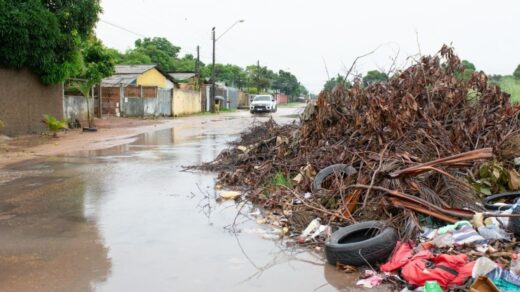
top-left (0, 0), bottom-right (101, 84)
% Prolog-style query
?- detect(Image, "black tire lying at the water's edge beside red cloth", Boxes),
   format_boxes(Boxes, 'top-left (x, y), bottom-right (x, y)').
top-left (325, 221), bottom-right (397, 266)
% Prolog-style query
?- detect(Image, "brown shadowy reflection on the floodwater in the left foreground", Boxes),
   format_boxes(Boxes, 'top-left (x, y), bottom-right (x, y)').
top-left (0, 163), bottom-right (111, 291)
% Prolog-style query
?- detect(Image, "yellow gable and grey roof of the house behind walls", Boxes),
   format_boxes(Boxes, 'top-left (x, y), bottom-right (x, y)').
top-left (102, 64), bottom-right (174, 89)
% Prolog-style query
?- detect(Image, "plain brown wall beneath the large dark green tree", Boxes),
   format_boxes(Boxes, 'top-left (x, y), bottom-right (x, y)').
top-left (0, 69), bottom-right (63, 136)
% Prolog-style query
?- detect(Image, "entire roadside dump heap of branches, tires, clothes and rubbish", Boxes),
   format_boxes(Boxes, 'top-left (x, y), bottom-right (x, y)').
top-left (198, 46), bottom-right (520, 291)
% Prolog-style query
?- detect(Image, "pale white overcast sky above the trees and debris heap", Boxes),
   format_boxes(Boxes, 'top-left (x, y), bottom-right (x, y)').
top-left (97, 0), bottom-right (520, 93)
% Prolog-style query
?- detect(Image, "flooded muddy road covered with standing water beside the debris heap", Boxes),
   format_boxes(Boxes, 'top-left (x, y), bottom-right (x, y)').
top-left (0, 109), bottom-right (366, 291)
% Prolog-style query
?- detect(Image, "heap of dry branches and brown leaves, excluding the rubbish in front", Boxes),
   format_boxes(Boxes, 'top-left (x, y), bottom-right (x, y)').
top-left (197, 46), bottom-right (520, 236)
